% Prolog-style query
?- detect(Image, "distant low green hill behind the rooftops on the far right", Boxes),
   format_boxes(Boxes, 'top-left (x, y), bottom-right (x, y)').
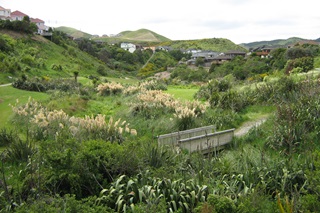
top-left (240, 37), bottom-right (319, 49)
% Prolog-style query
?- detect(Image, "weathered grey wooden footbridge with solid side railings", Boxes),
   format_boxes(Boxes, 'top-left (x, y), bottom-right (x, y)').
top-left (158, 126), bottom-right (235, 154)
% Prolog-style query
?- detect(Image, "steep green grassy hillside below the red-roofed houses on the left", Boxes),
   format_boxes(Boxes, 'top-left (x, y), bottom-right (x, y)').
top-left (0, 31), bottom-right (109, 84)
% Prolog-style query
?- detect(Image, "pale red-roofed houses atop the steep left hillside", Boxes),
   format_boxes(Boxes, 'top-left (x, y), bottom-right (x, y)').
top-left (0, 6), bottom-right (49, 34)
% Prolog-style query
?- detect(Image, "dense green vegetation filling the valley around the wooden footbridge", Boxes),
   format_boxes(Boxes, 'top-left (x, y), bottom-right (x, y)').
top-left (0, 29), bottom-right (320, 213)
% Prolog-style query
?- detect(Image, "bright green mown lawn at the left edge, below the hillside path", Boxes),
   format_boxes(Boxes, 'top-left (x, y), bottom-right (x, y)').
top-left (0, 86), bottom-right (49, 128)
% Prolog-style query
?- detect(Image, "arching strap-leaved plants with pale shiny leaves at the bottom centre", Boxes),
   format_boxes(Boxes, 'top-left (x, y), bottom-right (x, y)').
top-left (97, 174), bottom-right (208, 212)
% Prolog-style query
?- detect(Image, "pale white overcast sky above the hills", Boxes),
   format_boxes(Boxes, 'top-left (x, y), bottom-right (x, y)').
top-left (0, 0), bottom-right (320, 44)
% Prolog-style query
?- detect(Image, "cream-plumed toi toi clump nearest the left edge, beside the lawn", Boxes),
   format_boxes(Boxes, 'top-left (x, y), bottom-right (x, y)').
top-left (12, 98), bottom-right (137, 142)
